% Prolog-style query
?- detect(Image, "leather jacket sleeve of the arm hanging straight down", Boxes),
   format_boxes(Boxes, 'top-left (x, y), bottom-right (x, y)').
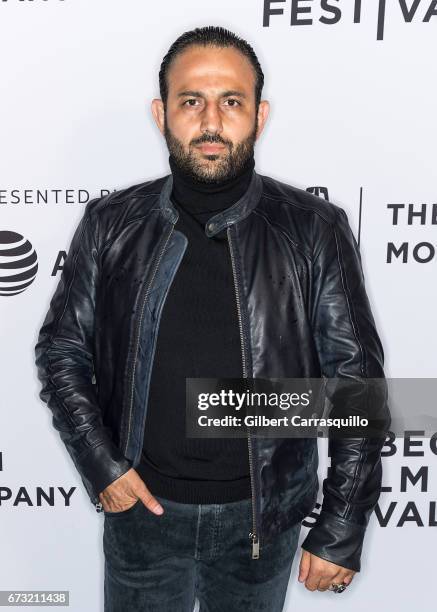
top-left (302, 205), bottom-right (390, 571)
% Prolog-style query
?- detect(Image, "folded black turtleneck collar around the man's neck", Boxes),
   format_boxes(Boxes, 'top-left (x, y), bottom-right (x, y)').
top-left (169, 155), bottom-right (255, 218)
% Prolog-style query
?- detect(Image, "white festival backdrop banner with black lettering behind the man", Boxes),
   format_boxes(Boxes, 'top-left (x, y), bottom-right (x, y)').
top-left (0, 0), bottom-right (437, 612)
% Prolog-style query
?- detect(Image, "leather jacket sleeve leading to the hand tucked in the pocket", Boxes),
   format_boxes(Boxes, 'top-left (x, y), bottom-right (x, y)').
top-left (35, 198), bottom-right (131, 504)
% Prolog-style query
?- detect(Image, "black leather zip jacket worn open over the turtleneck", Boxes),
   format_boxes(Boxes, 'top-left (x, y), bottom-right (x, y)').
top-left (35, 171), bottom-right (388, 571)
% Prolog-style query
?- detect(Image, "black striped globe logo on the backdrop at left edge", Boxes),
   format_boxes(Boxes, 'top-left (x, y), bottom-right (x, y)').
top-left (0, 230), bottom-right (38, 297)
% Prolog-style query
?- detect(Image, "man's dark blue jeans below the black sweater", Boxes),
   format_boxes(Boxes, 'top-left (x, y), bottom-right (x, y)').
top-left (103, 496), bottom-right (301, 612)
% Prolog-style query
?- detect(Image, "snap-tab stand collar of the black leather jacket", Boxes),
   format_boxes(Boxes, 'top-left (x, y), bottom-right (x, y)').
top-left (159, 170), bottom-right (263, 238)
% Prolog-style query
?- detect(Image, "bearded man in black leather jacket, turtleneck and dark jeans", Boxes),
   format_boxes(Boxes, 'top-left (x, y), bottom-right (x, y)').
top-left (36, 27), bottom-right (388, 612)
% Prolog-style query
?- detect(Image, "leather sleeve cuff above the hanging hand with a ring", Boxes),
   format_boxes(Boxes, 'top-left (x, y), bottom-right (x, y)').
top-left (302, 511), bottom-right (366, 572)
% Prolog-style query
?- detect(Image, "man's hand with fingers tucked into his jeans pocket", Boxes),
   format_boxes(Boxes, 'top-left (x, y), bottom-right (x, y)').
top-left (99, 468), bottom-right (164, 514)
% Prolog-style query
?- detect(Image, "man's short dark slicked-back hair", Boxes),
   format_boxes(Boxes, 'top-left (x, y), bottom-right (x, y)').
top-left (159, 26), bottom-right (264, 108)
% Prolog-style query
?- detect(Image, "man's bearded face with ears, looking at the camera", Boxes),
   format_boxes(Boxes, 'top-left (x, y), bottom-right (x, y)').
top-left (152, 46), bottom-right (267, 183)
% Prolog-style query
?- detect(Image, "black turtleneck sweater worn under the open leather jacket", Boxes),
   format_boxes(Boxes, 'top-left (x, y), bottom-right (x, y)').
top-left (136, 156), bottom-right (255, 504)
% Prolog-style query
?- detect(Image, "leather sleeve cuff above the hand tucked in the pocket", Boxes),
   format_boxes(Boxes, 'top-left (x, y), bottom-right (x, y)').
top-left (77, 440), bottom-right (132, 503)
